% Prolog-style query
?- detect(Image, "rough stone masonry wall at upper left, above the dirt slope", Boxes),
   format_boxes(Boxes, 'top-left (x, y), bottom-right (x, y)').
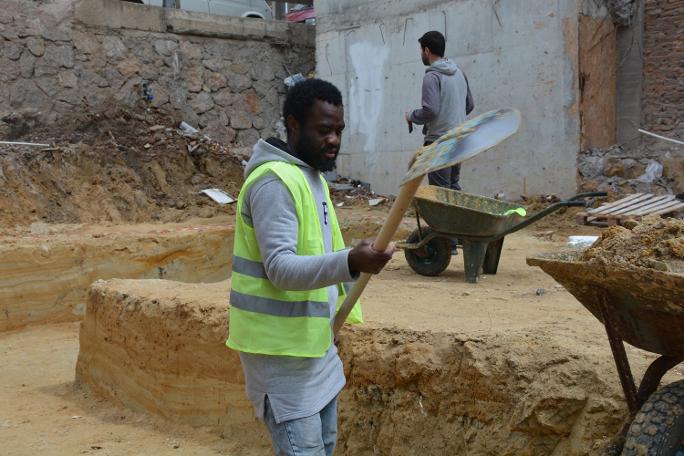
top-left (0, 0), bottom-right (314, 145)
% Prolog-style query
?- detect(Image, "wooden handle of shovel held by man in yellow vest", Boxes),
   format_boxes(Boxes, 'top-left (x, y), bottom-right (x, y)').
top-left (333, 176), bottom-right (423, 334)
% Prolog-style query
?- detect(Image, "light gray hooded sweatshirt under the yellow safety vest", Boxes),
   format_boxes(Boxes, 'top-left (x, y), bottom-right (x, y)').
top-left (234, 139), bottom-right (353, 423)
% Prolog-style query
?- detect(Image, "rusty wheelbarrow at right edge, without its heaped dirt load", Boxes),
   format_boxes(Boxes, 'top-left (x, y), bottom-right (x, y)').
top-left (527, 253), bottom-right (684, 456)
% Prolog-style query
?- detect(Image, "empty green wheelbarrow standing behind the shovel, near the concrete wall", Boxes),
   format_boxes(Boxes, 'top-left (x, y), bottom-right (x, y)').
top-left (397, 185), bottom-right (606, 283)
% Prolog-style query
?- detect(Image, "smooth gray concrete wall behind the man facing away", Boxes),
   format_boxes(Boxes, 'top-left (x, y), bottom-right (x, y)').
top-left (316, 0), bottom-right (596, 198)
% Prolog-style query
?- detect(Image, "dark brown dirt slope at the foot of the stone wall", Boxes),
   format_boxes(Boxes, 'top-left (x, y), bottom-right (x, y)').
top-left (0, 109), bottom-right (246, 227)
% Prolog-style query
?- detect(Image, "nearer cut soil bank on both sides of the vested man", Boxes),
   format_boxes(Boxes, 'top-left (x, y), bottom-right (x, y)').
top-left (76, 280), bottom-right (626, 455)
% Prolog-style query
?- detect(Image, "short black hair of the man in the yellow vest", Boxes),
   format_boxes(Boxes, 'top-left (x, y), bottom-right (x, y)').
top-left (283, 79), bottom-right (342, 132)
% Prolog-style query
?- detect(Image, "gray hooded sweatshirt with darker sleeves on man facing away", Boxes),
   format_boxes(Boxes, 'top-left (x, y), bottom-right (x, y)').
top-left (410, 59), bottom-right (474, 142)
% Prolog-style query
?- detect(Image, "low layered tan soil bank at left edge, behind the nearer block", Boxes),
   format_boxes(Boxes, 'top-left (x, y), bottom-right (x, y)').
top-left (0, 224), bottom-right (233, 331)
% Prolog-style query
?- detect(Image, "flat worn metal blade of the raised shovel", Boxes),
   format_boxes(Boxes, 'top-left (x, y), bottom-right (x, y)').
top-left (401, 108), bottom-right (520, 185)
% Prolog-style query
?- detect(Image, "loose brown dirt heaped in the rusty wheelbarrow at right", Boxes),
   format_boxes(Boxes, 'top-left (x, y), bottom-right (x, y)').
top-left (581, 217), bottom-right (684, 273)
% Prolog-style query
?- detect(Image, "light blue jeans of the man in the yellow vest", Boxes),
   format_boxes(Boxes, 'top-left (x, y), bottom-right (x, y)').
top-left (264, 396), bottom-right (337, 456)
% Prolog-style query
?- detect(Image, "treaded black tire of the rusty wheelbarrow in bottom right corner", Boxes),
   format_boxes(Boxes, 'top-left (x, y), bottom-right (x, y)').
top-left (622, 380), bottom-right (684, 456)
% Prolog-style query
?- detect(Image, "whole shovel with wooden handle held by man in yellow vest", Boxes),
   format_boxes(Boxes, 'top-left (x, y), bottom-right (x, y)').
top-left (333, 109), bottom-right (520, 334)
